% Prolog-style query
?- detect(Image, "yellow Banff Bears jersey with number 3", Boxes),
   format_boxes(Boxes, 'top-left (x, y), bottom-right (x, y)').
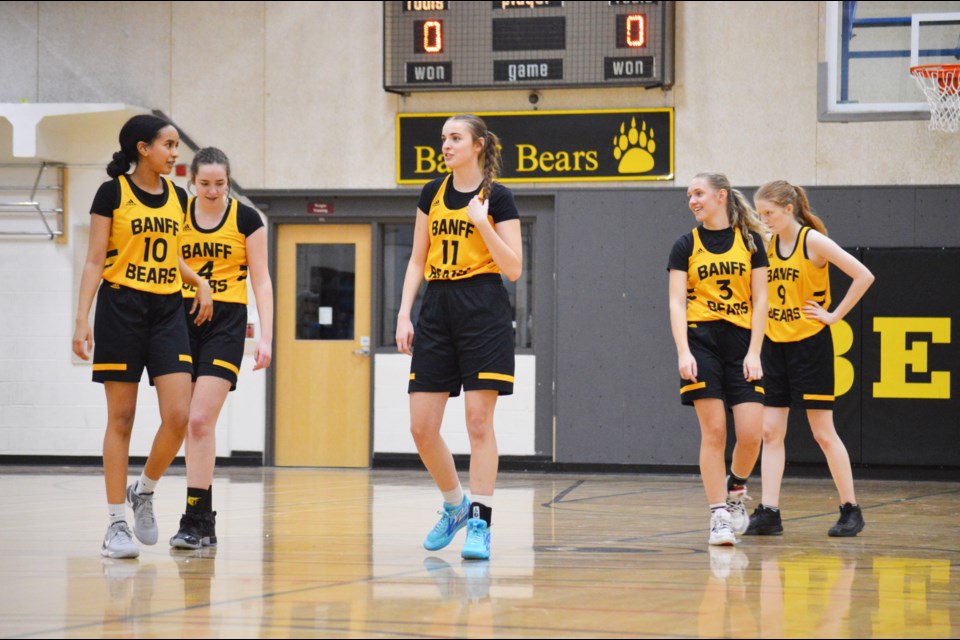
top-left (687, 227), bottom-right (753, 329)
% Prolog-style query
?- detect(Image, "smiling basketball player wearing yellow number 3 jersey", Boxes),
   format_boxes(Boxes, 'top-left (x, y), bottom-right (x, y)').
top-left (668, 173), bottom-right (767, 545)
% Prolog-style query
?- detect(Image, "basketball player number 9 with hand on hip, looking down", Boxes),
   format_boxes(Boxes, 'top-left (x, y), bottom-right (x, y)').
top-left (747, 180), bottom-right (873, 536)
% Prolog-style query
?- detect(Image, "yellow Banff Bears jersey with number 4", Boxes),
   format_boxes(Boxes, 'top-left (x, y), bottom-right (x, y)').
top-left (180, 198), bottom-right (248, 304)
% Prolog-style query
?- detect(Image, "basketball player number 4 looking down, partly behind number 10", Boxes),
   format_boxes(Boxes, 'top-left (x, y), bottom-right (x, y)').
top-left (170, 147), bottom-right (273, 549)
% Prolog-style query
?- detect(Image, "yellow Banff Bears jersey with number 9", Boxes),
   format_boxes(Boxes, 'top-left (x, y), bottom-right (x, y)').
top-left (767, 227), bottom-right (830, 342)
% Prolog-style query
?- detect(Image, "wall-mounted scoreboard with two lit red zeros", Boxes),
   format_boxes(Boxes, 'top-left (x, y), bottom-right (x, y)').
top-left (383, 0), bottom-right (674, 93)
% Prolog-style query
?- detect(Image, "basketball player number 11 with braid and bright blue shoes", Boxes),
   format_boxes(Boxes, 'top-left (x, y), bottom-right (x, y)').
top-left (396, 115), bottom-right (523, 559)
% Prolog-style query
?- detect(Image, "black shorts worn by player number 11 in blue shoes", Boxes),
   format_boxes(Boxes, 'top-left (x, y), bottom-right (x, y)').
top-left (407, 274), bottom-right (514, 396)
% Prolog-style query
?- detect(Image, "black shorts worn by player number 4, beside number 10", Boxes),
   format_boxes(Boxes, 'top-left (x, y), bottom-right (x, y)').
top-left (183, 298), bottom-right (247, 391)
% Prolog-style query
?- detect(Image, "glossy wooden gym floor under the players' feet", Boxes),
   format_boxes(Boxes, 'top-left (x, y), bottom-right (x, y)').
top-left (0, 467), bottom-right (960, 638)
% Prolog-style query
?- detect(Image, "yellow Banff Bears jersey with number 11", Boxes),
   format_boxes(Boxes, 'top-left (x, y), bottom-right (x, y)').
top-left (423, 176), bottom-right (500, 280)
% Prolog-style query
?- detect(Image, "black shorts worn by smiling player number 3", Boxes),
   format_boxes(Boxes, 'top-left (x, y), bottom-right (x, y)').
top-left (680, 320), bottom-right (764, 407)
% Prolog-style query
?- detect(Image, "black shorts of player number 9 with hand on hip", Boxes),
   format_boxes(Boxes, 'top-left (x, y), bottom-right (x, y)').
top-left (761, 326), bottom-right (834, 410)
